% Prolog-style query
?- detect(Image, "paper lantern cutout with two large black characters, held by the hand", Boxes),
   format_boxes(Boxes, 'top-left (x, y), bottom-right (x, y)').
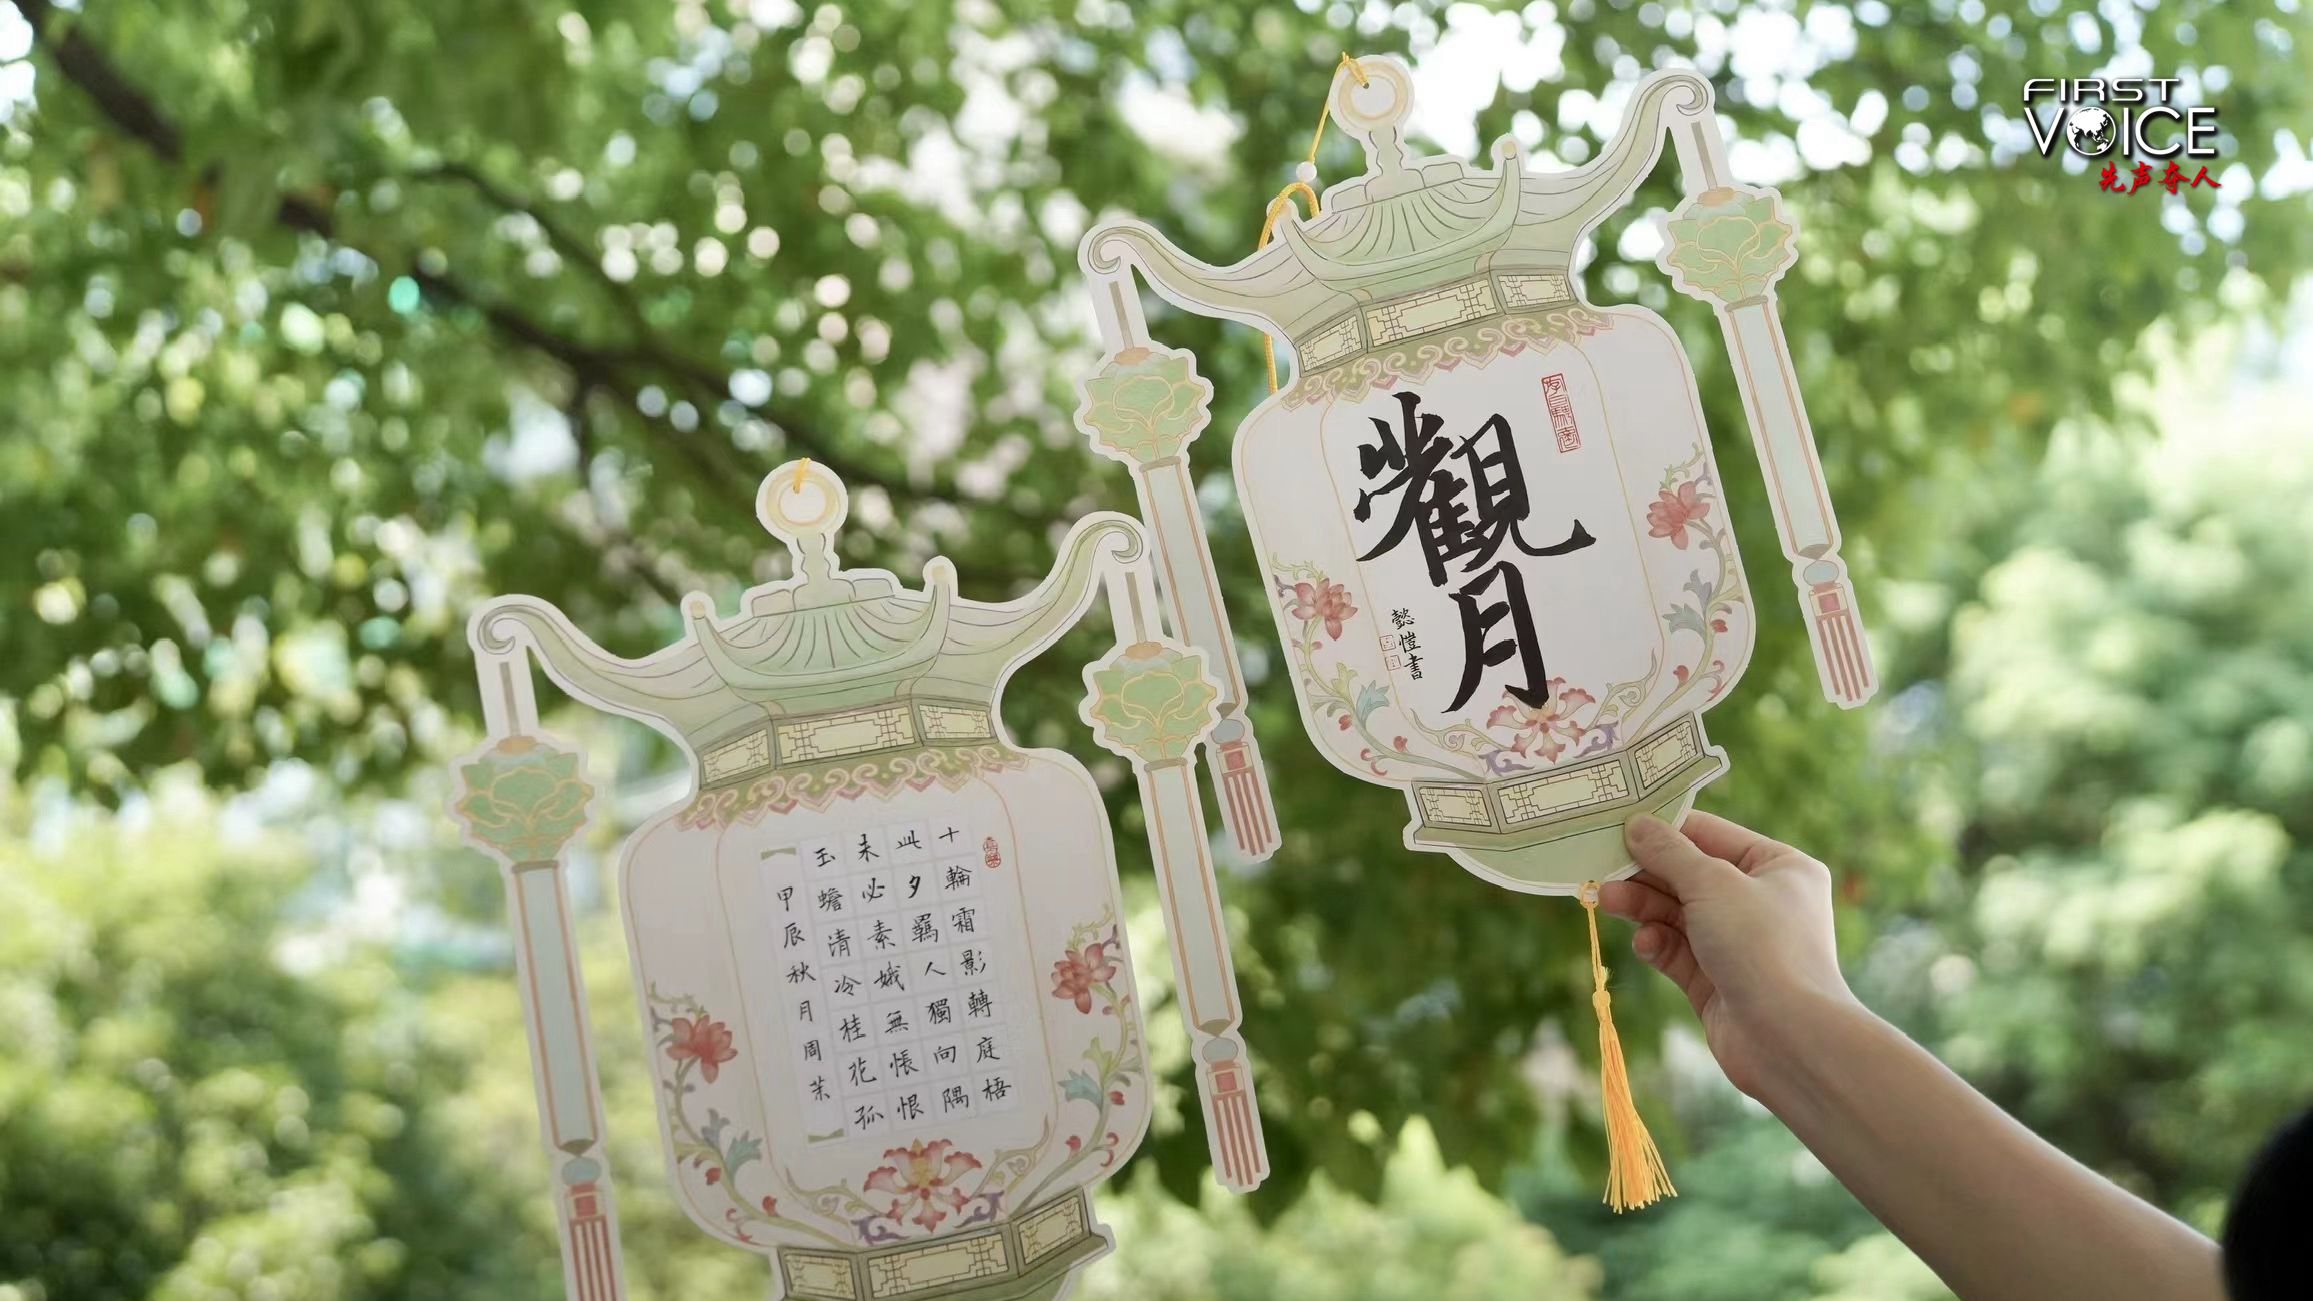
top-left (1078, 58), bottom-right (1871, 891)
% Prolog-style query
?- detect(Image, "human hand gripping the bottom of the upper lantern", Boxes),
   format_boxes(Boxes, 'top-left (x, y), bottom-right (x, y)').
top-left (1598, 810), bottom-right (1855, 1102)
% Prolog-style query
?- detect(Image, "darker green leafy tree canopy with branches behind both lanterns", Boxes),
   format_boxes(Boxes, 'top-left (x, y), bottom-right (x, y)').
top-left (0, 0), bottom-right (2313, 1250)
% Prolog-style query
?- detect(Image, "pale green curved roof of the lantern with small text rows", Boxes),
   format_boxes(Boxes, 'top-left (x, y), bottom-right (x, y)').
top-left (476, 461), bottom-right (1138, 787)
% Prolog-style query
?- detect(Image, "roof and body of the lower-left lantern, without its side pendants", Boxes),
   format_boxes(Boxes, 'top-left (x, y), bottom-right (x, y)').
top-left (470, 470), bottom-right (1151, 1301)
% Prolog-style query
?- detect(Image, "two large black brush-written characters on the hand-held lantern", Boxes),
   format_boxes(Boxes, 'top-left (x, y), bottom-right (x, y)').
top-left (1355, 391), bottom-right (1596, 711)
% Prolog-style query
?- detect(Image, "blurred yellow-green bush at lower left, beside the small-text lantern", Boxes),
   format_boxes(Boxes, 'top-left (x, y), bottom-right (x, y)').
top-left (0, 787), bottom-right (539, 1301)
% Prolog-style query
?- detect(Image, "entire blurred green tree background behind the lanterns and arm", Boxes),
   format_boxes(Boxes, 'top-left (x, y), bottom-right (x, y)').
top-left (0, 0), bottom-right (2313, 1301)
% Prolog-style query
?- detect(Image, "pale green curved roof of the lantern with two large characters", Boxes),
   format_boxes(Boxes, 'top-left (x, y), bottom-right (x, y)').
top-left (1085, 58), bottom-right (1709, 373)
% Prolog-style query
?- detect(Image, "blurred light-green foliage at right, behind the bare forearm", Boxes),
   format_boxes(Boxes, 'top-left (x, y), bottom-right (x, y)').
top-left (1513, 351), bottom-right (2313, 1301)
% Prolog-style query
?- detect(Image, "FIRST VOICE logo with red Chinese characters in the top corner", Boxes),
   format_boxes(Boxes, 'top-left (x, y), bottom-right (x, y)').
top-left (2024, 76), bottom-right (2220, 197)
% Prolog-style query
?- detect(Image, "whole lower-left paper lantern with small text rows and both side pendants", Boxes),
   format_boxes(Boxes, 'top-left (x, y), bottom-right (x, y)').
top-left (458, 463), bottom-right (1265, 1301)
